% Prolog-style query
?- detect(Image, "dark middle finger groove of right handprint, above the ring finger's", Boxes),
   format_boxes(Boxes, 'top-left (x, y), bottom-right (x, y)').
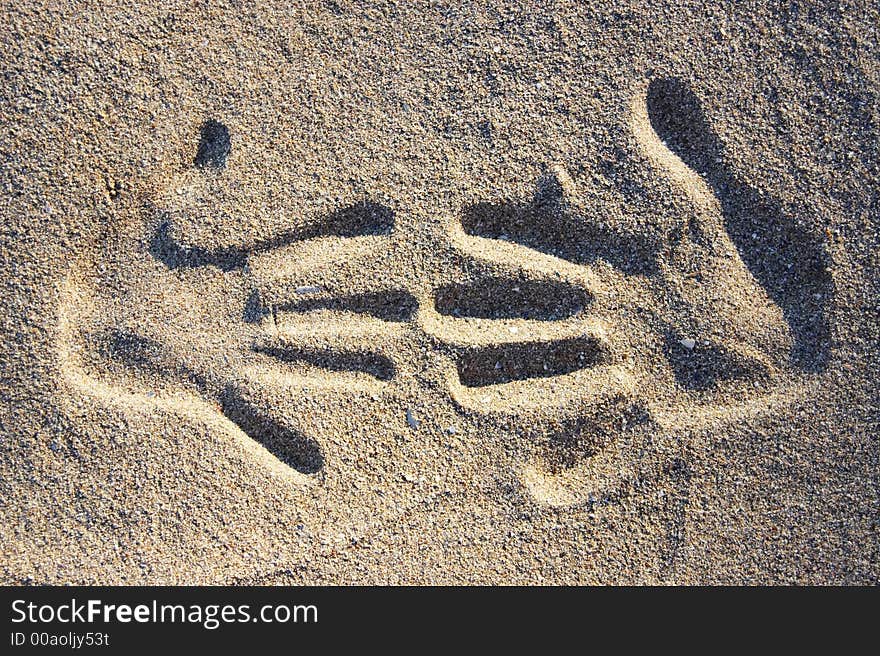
top-left (434, 276), bottom-right (592, 321)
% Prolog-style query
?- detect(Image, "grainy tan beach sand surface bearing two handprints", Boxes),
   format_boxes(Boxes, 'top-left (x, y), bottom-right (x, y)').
top-left (0, 0), bottom-right (880, 584)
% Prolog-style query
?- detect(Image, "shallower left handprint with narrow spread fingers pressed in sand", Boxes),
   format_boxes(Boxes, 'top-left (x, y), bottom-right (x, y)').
top-left (62, 187), bottom-right (415, 480)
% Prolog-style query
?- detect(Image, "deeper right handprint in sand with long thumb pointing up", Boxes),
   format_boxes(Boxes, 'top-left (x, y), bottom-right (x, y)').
top-left (419, 80), bottom-right (832, 504)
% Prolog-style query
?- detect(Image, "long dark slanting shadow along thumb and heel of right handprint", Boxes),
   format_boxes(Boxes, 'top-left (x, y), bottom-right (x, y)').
top-left (646, 78), bottom-right (833, 370)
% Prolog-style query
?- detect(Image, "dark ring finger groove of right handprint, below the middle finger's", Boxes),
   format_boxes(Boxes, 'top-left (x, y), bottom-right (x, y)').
top-left (458, 337), bottom-right (603, 387)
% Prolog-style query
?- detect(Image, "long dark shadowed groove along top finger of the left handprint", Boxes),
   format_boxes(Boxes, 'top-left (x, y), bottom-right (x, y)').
top-left (149, 201), bottom-right (394, 271)
